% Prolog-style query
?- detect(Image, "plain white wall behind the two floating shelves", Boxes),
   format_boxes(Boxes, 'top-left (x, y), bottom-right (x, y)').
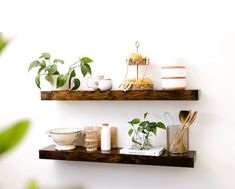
top-left (0, 0), bottom-right (235, 189)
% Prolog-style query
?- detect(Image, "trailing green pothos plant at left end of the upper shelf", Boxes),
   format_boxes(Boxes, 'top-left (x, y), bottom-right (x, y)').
top-left (28, 53), bottom-right (93, 90)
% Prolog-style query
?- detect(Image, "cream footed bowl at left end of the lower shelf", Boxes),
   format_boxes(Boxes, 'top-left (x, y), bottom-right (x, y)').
top-left (47, 128), bottom-right (82, 151)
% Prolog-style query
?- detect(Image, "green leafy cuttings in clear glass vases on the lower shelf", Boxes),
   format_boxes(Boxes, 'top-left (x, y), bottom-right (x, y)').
top-left (128, 112), bottom-right (166, 149)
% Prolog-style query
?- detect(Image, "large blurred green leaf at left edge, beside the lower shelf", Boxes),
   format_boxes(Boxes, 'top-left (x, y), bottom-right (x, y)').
top-left (0, 120), bottom-right (30, 156)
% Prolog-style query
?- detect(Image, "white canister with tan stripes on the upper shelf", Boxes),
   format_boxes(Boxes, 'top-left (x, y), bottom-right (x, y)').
top-left (161, 66), bottom-right (186, 90)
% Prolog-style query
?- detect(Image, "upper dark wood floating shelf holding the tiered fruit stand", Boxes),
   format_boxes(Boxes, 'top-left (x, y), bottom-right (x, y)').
top-left (41, 90), bottom-right (199, 100)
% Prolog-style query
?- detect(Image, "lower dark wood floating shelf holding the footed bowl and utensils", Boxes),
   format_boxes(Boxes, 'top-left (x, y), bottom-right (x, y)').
top-left (39, 145), bottom-right (196, 168)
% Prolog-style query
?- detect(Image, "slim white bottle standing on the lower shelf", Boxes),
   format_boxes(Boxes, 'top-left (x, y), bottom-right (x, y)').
top-left (101, 123), bottom-right (111, 151)
